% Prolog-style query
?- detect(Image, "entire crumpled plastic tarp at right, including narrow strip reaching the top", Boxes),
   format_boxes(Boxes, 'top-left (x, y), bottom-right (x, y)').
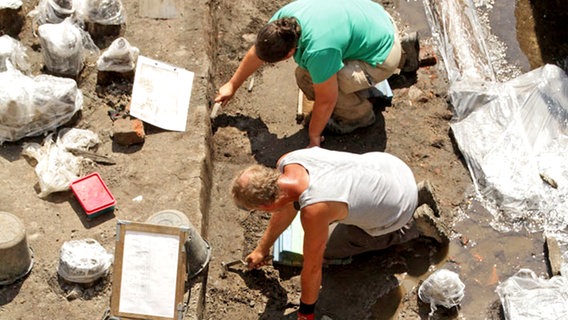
top-left (423, 0), bottom-right (568, 272)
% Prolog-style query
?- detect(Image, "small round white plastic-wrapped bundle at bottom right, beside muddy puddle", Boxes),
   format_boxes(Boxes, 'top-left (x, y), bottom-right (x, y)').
top-left (418, 269), bottom-right (465, 316)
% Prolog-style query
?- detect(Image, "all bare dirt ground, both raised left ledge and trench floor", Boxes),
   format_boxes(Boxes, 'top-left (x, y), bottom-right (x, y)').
top-left (0, 0), bottom-right (478, 319)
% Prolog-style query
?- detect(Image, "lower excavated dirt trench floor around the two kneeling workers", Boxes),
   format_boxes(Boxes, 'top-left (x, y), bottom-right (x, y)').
top-left (207, 1), bottom-right (471, 319)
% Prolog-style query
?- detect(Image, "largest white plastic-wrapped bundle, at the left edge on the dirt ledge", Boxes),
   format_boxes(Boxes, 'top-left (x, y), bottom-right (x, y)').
top-left (0, 66), bottom-right (83, 144)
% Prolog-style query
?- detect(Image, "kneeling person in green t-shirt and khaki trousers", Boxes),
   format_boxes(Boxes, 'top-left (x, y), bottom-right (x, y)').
top-left (215, 0), bottom-right (418, 147)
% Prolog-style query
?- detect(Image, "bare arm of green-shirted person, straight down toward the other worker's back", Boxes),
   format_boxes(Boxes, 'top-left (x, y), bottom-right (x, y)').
top-left (308, 74), bottom-right (338, 147)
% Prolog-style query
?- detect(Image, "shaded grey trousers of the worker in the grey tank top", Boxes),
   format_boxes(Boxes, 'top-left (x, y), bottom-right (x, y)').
top-left (324, 219), bottom-right (419, 259)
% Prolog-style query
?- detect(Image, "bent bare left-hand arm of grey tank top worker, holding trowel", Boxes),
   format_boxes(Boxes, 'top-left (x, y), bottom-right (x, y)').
top-left (246, 203), bottom-right (297, 268)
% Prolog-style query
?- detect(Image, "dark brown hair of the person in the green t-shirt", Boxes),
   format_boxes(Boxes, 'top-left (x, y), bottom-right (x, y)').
top-left (255, 18), bottom-right (300, 63)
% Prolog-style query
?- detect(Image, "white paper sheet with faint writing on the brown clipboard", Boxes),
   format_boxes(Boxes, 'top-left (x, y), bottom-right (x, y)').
top-left (119, 230), bottom-right (180, 319)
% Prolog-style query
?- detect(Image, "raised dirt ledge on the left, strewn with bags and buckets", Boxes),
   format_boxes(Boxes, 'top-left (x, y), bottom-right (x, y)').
top-left (0, 1), bottom-right (211, 320)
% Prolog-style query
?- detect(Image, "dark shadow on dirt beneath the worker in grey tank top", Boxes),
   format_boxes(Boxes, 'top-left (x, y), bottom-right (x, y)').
top-left (220, 238), bottom-right (446, 320)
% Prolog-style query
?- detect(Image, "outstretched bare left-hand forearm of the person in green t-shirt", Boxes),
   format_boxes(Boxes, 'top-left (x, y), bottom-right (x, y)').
top-left (215, 45), bottom-right (264, 104)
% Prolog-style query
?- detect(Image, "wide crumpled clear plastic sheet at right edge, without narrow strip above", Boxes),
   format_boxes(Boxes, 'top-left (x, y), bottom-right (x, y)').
top-left (451, 65), bottom-right (568, 232)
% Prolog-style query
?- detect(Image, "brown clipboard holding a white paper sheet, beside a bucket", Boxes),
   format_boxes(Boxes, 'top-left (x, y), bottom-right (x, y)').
top-left (109, 221), bottom-right (189, 320)
